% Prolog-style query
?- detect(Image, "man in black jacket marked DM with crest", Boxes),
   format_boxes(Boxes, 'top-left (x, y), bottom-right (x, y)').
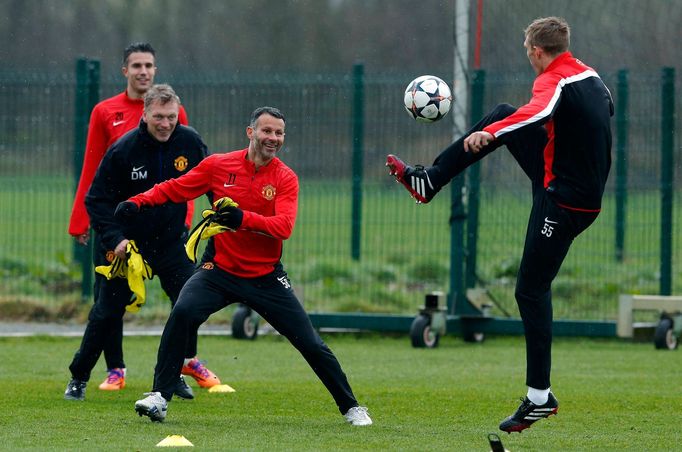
top-left (64, 85), bottom-right (220, 400)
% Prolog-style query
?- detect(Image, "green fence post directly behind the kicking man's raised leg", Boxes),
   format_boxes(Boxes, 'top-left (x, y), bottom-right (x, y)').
top-left (464, 69), bottom-right (485, 288)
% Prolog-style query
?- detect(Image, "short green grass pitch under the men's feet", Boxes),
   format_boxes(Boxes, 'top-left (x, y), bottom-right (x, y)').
top-left (0, 334), bottom-right (682, 451)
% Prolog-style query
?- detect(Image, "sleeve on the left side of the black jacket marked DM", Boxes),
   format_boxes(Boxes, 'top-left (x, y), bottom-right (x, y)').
top-left (85, 149), bottom-right (126, 250)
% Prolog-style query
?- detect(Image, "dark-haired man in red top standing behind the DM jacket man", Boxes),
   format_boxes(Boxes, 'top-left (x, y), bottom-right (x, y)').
top-left (69, 42), bottom-right (213, 391)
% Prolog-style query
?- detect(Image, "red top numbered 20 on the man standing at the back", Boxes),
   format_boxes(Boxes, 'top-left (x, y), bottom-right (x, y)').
top-left (69, 91), bottom-right (194, 237)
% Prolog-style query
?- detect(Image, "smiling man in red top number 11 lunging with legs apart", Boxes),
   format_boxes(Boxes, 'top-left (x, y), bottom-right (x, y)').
top-left (116, 107), bottom-right (372, 426)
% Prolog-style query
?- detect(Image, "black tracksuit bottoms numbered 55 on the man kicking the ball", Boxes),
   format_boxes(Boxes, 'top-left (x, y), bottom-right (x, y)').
top-left (428, 104), bottom-right (598, 389)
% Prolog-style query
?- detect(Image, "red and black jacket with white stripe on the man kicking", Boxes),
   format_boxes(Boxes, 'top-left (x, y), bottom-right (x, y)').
top-left (483, 52), bottom-right (613, 212)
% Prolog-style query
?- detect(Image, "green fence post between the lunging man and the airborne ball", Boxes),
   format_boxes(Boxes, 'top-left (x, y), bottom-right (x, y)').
top-left (351, 63), bottom-right (365, 261)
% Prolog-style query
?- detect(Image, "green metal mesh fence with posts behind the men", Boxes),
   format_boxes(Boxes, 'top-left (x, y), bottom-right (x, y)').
top-left (0, 61), bottom-right (682, 325)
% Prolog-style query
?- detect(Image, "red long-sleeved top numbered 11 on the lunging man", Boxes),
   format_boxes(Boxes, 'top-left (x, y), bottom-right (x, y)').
top-left (129, 149), bottom-right (298, 278)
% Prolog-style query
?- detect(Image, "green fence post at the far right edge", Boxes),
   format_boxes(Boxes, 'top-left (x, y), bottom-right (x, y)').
top-left (659, 67), bottom-right (675, 295)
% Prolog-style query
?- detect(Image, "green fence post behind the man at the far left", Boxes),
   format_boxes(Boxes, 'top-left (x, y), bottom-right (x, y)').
top-left (73, 58), bottom-right (100, 300)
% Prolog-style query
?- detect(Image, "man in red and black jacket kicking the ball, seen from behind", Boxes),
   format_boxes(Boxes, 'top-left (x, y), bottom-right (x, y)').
top-left (386, 17), bottom-right (613, 432)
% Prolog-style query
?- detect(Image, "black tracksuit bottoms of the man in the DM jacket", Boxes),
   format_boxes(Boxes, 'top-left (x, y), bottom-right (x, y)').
top-left (69, 240), bottom-right (197, 383)
